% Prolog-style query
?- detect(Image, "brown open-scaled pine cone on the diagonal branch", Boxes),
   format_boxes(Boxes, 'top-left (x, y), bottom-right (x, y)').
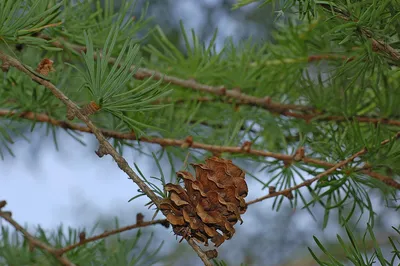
top-left (160, 157), bottom-right (248, 247)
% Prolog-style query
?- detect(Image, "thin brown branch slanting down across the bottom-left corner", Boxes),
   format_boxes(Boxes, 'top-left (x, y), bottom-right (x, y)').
top-left (0, 200), bottom-right (75, 266)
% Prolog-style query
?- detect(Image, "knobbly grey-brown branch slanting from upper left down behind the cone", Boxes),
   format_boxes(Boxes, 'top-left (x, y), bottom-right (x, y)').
top-left (0, 51), bottom-right (212, 266)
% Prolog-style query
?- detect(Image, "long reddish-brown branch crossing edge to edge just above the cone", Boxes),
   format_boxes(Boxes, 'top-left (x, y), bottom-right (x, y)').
top-left (0, 109), bottom-right (400, 189)
